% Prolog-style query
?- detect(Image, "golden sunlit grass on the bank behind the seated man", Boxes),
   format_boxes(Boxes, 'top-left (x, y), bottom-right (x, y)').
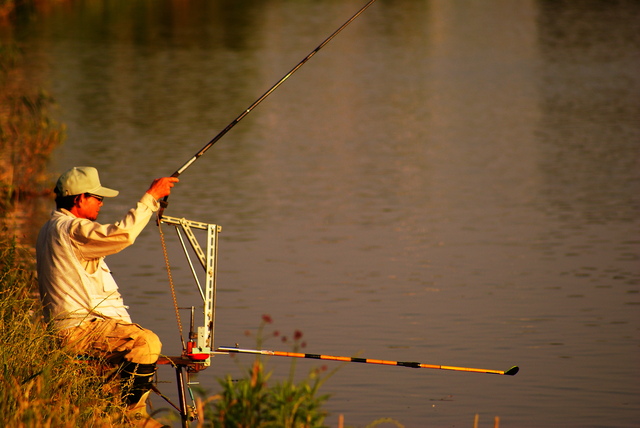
top-left (0, 236), bottom-right (127, 427)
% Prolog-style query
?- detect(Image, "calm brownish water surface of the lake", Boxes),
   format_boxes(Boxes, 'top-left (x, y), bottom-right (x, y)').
top-left (16, 0), bottom-right (640, 427)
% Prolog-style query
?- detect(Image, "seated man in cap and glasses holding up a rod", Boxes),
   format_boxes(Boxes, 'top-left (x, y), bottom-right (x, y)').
top-left (36, 167), bottom-right (179, 427)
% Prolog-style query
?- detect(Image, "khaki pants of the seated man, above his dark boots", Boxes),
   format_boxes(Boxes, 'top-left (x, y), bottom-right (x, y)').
top-left (59, 318), bottom-right (162, 364)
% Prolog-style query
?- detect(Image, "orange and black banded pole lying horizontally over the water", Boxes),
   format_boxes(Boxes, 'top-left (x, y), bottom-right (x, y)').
top-left (216, 346), bottom-right (520, 376)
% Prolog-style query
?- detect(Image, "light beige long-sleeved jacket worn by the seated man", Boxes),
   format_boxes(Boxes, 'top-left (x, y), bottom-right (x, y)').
top-left (36, 193), bottom-right (159, 329)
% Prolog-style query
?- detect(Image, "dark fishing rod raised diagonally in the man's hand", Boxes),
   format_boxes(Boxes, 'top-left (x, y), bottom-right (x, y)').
top-left (158, 0), bottom-right (376, 218)
